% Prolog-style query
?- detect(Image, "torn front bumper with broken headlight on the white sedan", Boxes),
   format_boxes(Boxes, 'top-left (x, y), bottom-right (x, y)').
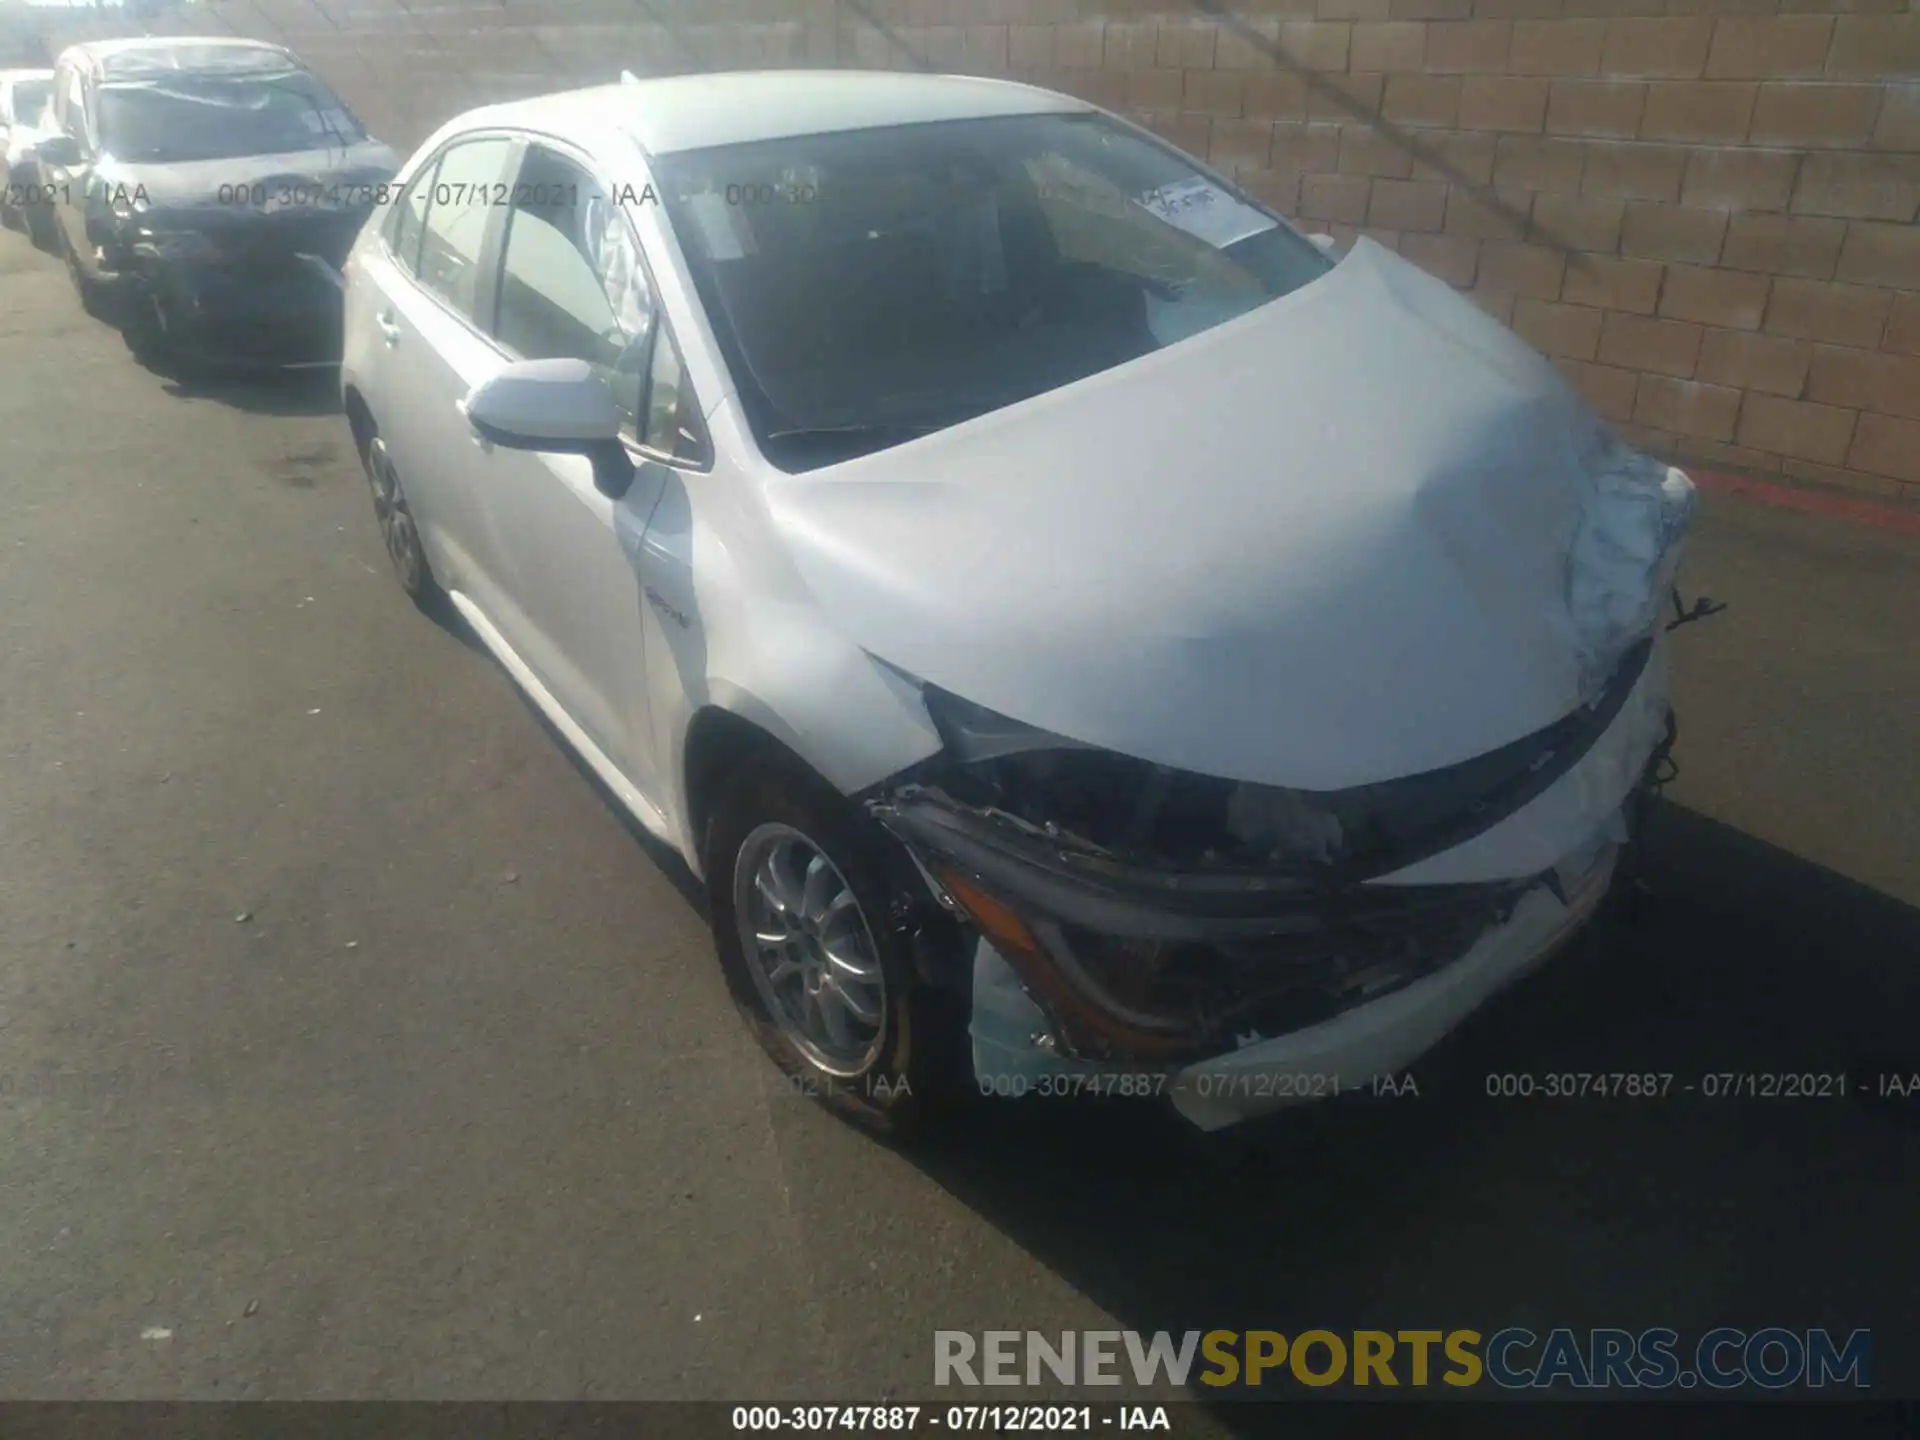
top-left (870, 637), bottom-right (1672, 1129)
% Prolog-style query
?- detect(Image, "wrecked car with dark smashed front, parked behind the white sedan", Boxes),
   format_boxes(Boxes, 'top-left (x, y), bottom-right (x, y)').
top-left (40, 38), bottom-right (397, 372)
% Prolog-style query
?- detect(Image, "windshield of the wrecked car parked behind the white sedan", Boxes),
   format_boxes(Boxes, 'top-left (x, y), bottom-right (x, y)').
top-left (100, 71), bottom-right (365, 163)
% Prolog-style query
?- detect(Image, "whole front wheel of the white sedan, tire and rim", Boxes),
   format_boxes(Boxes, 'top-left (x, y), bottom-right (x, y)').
top-left (705, 758), bottom-right (966, 1139)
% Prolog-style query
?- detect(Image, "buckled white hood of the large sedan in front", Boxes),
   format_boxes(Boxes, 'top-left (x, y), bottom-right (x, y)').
top-left (768, 240), bottom-right (1643, 789)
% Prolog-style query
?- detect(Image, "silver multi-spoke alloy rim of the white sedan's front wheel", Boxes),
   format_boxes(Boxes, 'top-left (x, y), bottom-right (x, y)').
top-left (733, 824), bottom-right (887, 1077)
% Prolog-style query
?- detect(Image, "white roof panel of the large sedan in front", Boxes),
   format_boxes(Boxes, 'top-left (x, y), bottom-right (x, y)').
top-left (468, 69), bottom-right (1091, 156)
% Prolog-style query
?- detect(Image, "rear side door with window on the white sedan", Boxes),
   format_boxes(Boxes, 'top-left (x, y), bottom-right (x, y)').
top-left (351, 134), bottom-right (516, 614)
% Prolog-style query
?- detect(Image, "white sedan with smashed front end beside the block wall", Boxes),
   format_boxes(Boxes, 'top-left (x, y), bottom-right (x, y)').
top-left (342, 71), bottom-right (1693, 1129)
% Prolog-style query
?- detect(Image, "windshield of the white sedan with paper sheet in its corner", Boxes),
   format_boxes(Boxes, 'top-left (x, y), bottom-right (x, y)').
top-left (657, 113), bottom-right (1331, 470)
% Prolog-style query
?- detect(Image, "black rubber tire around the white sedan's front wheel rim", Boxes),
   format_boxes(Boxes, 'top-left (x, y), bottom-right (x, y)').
top-left (703, 755), bottom-right (966, 1140)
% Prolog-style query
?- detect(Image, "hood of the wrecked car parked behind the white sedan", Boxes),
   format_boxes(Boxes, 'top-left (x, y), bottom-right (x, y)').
top-left (96, 140), bottom-right (399, 215)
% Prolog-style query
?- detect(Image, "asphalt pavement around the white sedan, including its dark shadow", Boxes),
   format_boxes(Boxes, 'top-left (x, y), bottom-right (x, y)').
top-left (0, 222), bottom-right (1920, 1428)
